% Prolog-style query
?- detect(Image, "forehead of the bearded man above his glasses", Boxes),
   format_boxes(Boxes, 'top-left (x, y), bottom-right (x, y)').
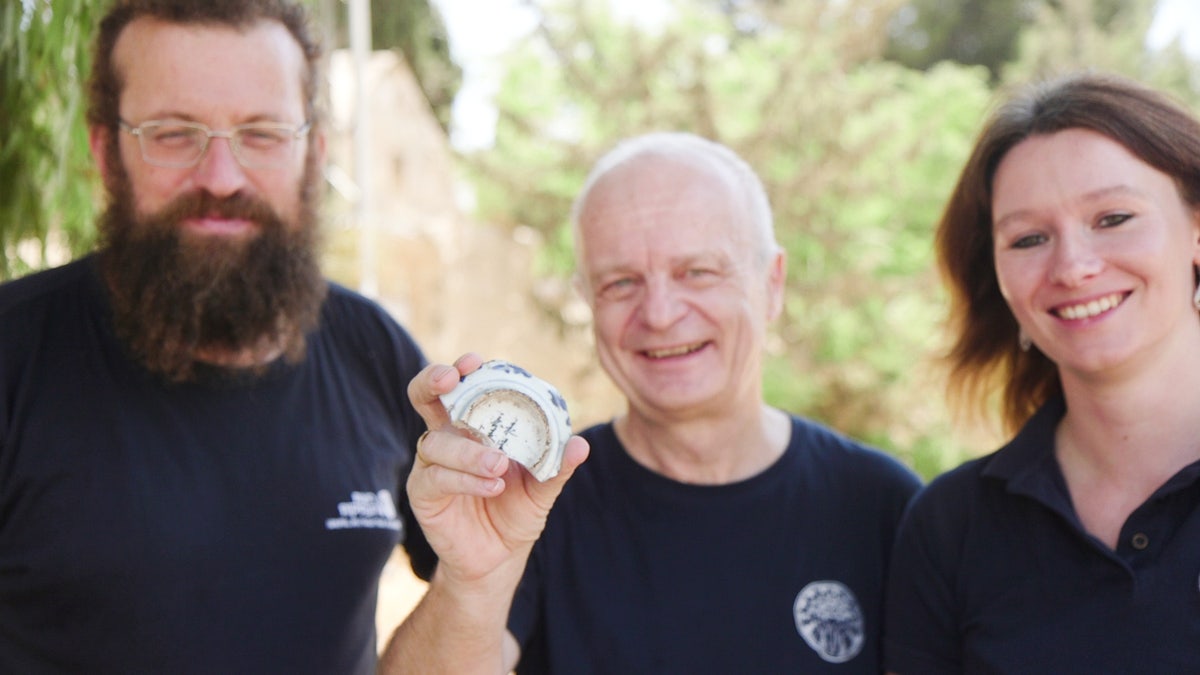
top-left (113, 18), bottom-right (307, 124)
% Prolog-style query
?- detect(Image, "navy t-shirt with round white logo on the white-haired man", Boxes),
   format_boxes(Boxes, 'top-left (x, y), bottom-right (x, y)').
top-left (509, 418), bottom-right (918, 675)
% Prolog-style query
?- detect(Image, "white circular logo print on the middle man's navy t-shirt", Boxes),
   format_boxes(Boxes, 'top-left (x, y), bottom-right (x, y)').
top-left (792, 581), bottom-right (865, 663)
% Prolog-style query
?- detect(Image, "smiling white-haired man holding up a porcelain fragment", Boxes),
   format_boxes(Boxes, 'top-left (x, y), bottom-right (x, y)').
top-left (385, 133), bottom-right (918, 675)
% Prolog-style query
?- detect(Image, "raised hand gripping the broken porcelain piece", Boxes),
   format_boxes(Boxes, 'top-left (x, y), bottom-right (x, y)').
top-left (408, 353), bottom-right (588, 583)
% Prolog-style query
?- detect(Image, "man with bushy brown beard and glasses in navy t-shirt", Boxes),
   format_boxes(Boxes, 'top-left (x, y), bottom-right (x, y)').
top-left (0, 0), bottom-right (433, 674)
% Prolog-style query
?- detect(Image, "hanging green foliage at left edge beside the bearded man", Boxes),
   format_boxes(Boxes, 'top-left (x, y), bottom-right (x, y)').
top-left (0, 0), bottom-right (96, 279)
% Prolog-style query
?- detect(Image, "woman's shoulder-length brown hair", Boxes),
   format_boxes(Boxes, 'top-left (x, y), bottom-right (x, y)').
top-left (936, 73), bottom-right (1200, 431)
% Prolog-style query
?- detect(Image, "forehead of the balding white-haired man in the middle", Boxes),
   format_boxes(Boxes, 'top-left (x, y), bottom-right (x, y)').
top-left (580, 156), bottom-right (752, 265)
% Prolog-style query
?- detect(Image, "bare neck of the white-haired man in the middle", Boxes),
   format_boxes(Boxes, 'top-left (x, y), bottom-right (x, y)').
top-left (614, 405), bottom-right (792, 485)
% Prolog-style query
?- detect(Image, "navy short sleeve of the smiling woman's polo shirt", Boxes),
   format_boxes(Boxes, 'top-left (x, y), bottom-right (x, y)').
top-left (883, 483), bottom-right (962, 675)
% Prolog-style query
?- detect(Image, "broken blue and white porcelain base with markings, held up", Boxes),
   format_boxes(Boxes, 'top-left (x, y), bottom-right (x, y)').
top-left (442, 360), bottom-right (571, 480)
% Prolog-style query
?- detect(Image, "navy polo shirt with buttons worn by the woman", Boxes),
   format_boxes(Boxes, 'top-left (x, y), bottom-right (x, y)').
top-left (884, 399), bottom-right (1200, 675)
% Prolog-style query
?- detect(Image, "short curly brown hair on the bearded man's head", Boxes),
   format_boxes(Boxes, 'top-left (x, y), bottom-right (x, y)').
top-left (88, 0), bottom-right (322, 130)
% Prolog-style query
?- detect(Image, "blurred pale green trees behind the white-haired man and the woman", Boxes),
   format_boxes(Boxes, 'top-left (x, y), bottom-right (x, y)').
top-left (464, 0), bottom-right (1192, 476)
